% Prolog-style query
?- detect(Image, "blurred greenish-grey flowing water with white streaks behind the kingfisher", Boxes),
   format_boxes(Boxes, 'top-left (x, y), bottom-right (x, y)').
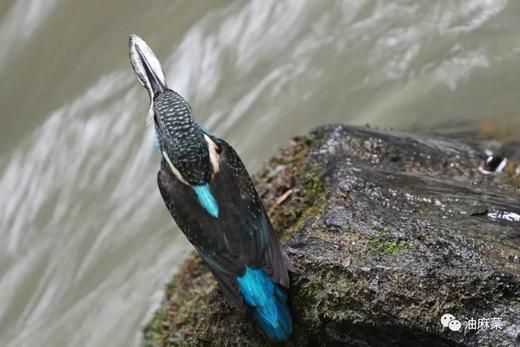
top-left (0, 0), bottom-right (520, 346)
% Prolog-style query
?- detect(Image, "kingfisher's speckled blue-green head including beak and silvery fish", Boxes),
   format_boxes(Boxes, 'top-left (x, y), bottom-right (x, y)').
top-left (130, 35), bottom-right (218, 186)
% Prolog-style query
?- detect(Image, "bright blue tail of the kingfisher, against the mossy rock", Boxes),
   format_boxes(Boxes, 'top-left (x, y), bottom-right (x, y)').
top-left (237, 267), bottom-right (292, 341)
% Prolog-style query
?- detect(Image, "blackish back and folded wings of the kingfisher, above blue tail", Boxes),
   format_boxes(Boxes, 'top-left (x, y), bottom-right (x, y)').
top-left (158, 137), bottom-right (290, 286)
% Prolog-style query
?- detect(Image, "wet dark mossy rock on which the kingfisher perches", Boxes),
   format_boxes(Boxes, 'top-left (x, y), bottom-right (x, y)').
top-left (144, 125), bottom-right (520, 346)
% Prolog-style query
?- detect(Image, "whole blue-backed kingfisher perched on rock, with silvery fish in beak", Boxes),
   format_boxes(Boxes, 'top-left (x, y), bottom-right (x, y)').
top-left (129, 35), bottom-right (294, 341)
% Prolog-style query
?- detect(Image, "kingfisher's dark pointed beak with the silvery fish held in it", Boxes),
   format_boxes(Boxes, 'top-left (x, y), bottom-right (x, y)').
top-left (129, 34), bottom-right (168, 123)
